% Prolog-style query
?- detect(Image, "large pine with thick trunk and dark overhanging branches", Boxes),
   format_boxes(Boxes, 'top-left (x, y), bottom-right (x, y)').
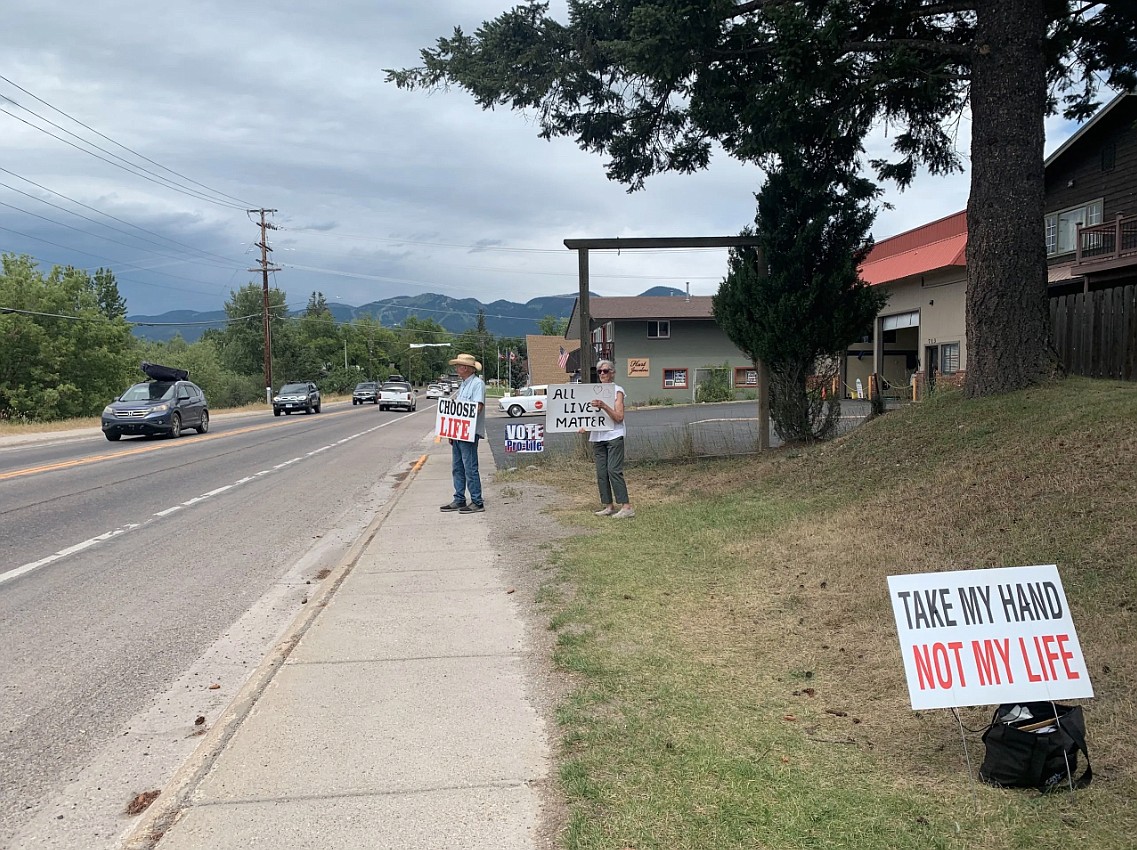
top-left (388, 0), bottom-right (1137, 395)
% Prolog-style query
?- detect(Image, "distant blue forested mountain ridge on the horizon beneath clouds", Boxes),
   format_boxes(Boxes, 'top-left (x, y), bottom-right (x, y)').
top-left (126, 286), bottom-right (686, 342)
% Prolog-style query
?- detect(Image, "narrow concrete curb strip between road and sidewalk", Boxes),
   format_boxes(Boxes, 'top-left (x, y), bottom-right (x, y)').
top-left (119, 453), bottom-right (429, 850)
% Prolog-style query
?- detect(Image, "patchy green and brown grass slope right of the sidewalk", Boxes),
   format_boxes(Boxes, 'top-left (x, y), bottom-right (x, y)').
top-left (536, 380), bottom-right (1137, 850)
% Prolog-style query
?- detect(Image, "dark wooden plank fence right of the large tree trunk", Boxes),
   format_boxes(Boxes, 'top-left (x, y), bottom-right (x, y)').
top-left (1051, 285), bottom-right (1137, 381)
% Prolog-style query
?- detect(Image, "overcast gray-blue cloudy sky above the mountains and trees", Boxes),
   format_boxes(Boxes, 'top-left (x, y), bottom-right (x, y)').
top-left (0, 0), bottom-right (1091, 315)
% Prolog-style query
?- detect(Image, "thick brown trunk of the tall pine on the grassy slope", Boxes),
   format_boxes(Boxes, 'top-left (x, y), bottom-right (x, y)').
top-left (965, 0), bottom-right (1052, 398)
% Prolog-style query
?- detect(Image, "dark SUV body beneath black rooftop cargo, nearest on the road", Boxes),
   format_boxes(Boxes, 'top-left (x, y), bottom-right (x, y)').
top-left (102, 381), bottom-right (209, 441)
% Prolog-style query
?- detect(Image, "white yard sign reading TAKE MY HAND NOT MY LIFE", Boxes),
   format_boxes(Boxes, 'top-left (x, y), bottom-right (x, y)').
top-left (888, 565), bottom-right (1094, 710)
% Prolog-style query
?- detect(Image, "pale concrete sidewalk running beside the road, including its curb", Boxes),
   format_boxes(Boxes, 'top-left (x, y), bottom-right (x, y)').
top-left (125, 440), bottom-right (549, 850)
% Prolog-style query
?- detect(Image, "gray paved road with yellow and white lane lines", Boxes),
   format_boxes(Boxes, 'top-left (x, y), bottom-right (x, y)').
top-left (0, 403), bottom-right (434, 850)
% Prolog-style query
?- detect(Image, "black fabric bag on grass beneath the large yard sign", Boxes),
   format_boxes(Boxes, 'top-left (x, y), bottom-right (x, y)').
top-left (979, 702), bottom-right (1094, 791)
